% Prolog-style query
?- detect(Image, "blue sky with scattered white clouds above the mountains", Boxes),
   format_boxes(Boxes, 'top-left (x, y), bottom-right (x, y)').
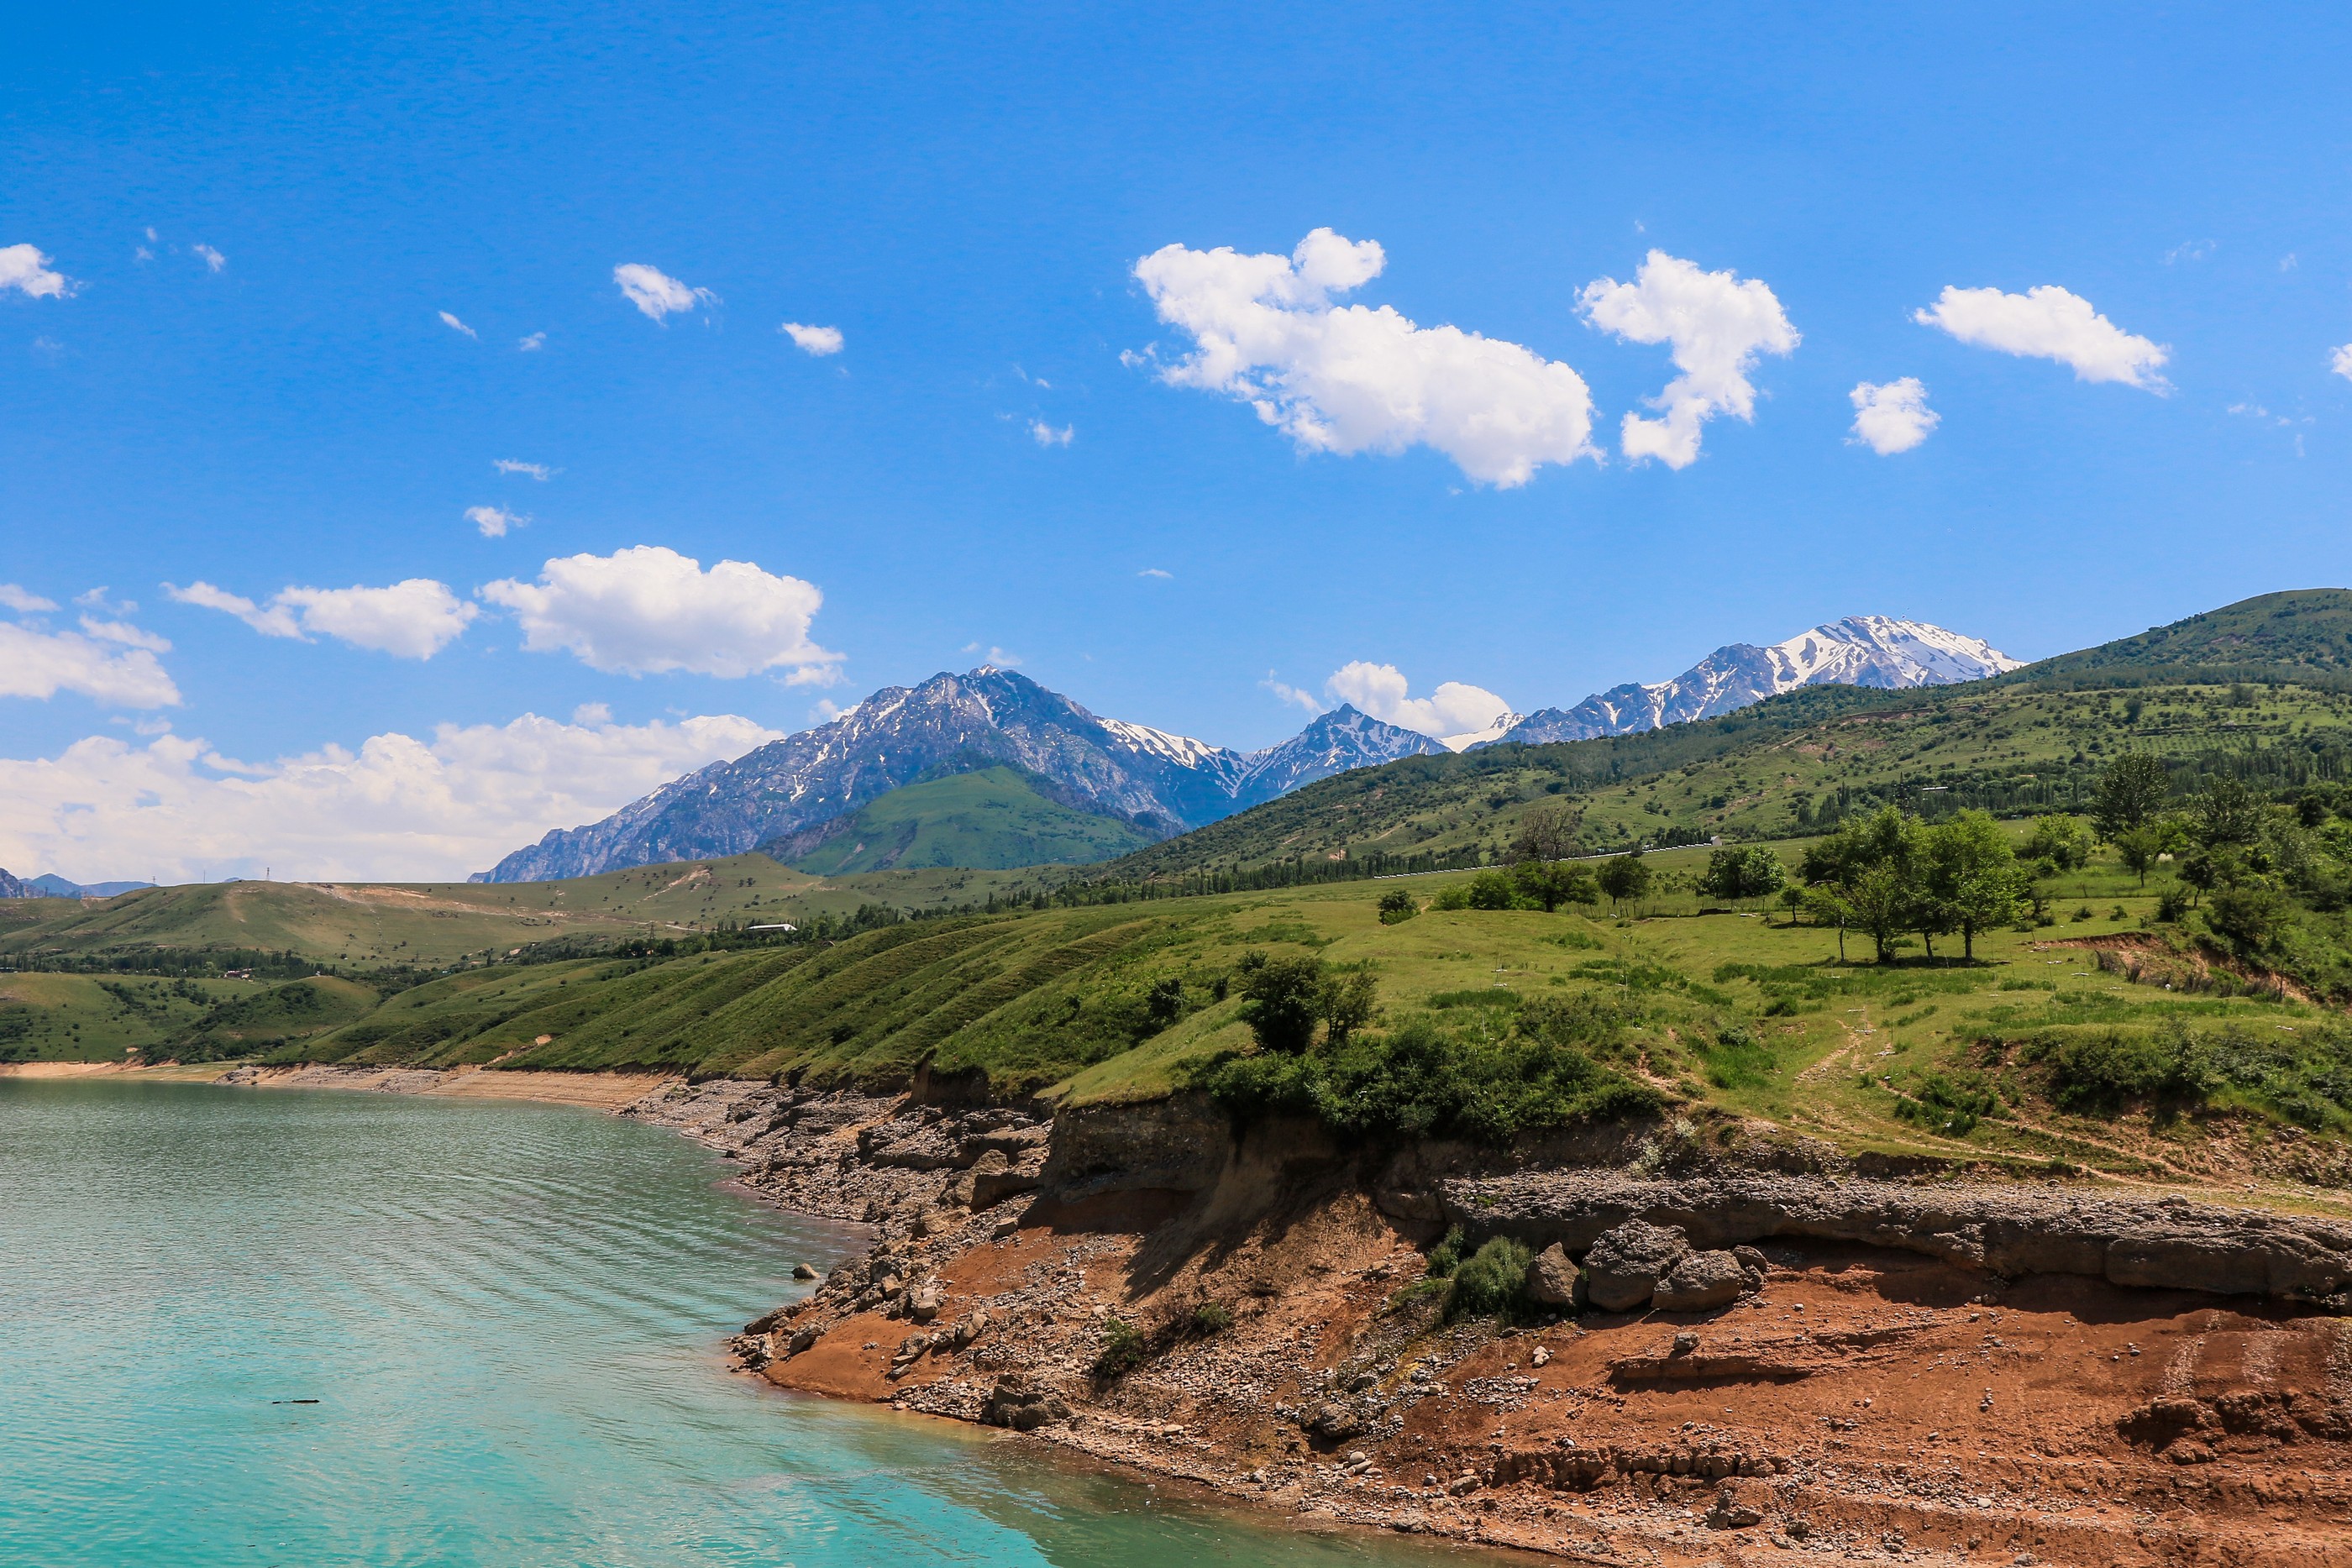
top-left (0, 5), bottom-right (2352, 879)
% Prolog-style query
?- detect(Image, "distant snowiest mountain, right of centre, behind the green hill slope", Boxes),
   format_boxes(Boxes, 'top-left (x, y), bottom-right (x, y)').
top-left (1484, 616), bottom-right (2023, 745)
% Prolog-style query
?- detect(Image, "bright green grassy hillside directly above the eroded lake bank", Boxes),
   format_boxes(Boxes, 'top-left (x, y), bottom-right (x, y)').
top-left (239, 844), bottom-right (2352, 1176)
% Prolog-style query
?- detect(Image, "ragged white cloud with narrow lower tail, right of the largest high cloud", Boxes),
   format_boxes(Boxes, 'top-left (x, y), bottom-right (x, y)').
top-left (1578, 252), bottom-right (1797, 468)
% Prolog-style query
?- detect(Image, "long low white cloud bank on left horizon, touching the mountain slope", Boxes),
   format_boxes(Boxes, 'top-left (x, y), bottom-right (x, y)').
top-left (0, 710), bottom-right (776, 882)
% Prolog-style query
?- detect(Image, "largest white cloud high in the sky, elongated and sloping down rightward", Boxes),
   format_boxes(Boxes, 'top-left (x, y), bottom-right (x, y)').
top-left (1136, 228), bottom-right (1597, 489)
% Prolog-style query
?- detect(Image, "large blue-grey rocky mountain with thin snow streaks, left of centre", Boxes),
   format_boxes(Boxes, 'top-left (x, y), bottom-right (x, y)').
top-left (485, 665), bottom-right (1440, 882)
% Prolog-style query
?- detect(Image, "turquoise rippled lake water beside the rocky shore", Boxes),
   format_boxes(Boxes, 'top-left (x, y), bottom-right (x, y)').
top-left (0, 1079), bottom-right (1496, 1568)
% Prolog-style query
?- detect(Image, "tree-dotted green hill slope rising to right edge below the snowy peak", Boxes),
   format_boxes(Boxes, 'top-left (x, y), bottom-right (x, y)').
top-left (1096, 590), bottom-right (2352, 886)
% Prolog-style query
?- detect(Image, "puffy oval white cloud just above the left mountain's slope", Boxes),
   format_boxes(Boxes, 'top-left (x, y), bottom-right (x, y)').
top-left (482, 545), bottom-right (842, 684)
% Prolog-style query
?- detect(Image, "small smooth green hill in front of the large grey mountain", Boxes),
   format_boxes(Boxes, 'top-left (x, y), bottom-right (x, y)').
top-left (762, 767), bottom-right (1152, 877)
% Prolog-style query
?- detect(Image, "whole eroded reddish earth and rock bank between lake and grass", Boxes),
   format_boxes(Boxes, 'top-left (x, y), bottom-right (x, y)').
top-left (630, 1079), bottom-right (2352, 1568)
